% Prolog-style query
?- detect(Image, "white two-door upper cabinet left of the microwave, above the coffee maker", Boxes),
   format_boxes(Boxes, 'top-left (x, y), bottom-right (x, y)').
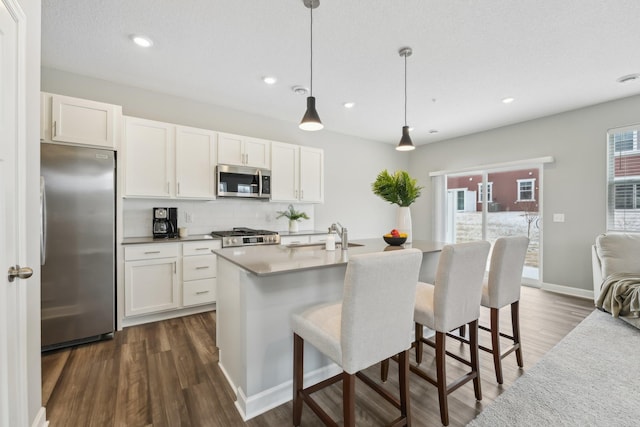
top-left (124, 117), bottom-right (216, 200)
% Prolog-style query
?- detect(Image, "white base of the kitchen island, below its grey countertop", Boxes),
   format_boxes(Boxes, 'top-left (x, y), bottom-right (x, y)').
top-left (216, 258), bottom-right (346, 419)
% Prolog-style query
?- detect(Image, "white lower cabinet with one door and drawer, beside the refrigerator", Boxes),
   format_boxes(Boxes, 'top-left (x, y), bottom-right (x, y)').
top-left (124, 243), bottom-right (180, 316)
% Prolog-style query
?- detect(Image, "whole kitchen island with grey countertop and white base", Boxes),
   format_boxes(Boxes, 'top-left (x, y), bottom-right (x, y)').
top-left (215, 239), bottom-right (444, 420)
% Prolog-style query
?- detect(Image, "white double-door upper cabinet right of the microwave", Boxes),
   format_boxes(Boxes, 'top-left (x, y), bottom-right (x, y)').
top-left (271, 142), bottom-right (324, 203)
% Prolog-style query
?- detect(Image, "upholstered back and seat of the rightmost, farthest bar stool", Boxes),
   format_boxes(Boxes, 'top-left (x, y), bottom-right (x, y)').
top-left (481, 236), bottom-right (529, 308)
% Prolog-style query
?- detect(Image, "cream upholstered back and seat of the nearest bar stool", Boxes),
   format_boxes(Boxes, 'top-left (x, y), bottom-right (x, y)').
top-left (292, 249), bottom-right (422, 374)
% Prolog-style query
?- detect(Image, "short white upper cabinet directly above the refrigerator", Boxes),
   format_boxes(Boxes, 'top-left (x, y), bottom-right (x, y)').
top-left (40, 93), bottom-right (122, 149)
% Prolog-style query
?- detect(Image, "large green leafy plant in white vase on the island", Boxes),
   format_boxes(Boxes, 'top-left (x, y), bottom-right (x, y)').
top-left (371, 169), bottom-right (424, 243)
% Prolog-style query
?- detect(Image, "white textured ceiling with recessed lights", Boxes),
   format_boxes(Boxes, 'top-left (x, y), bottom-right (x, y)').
top-left (42, 0), bottom-right (640, 145)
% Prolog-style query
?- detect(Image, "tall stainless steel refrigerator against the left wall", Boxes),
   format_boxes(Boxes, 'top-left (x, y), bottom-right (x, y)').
top-left (40, 144), bottom-right (116, 351)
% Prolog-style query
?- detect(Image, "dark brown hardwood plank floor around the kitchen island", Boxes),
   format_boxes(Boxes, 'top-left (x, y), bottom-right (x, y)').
top-left (42, 287), bottom-right (593, 427)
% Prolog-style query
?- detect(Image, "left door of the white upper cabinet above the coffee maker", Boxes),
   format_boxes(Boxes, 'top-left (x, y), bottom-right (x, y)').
top-left (124, 117), bottom-right (175, 197)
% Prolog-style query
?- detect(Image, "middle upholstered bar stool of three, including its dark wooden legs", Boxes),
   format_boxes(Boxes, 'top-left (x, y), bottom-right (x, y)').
top-left (410, 241), bottom-right (491, 425)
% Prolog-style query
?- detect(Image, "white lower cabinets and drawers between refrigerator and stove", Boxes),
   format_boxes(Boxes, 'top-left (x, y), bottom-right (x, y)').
top-left (124, 240), bottom-right (221, 323)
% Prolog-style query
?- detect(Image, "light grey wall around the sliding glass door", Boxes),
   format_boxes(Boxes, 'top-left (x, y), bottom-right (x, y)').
top-left (409, 96), bottom-right (640, 294)
